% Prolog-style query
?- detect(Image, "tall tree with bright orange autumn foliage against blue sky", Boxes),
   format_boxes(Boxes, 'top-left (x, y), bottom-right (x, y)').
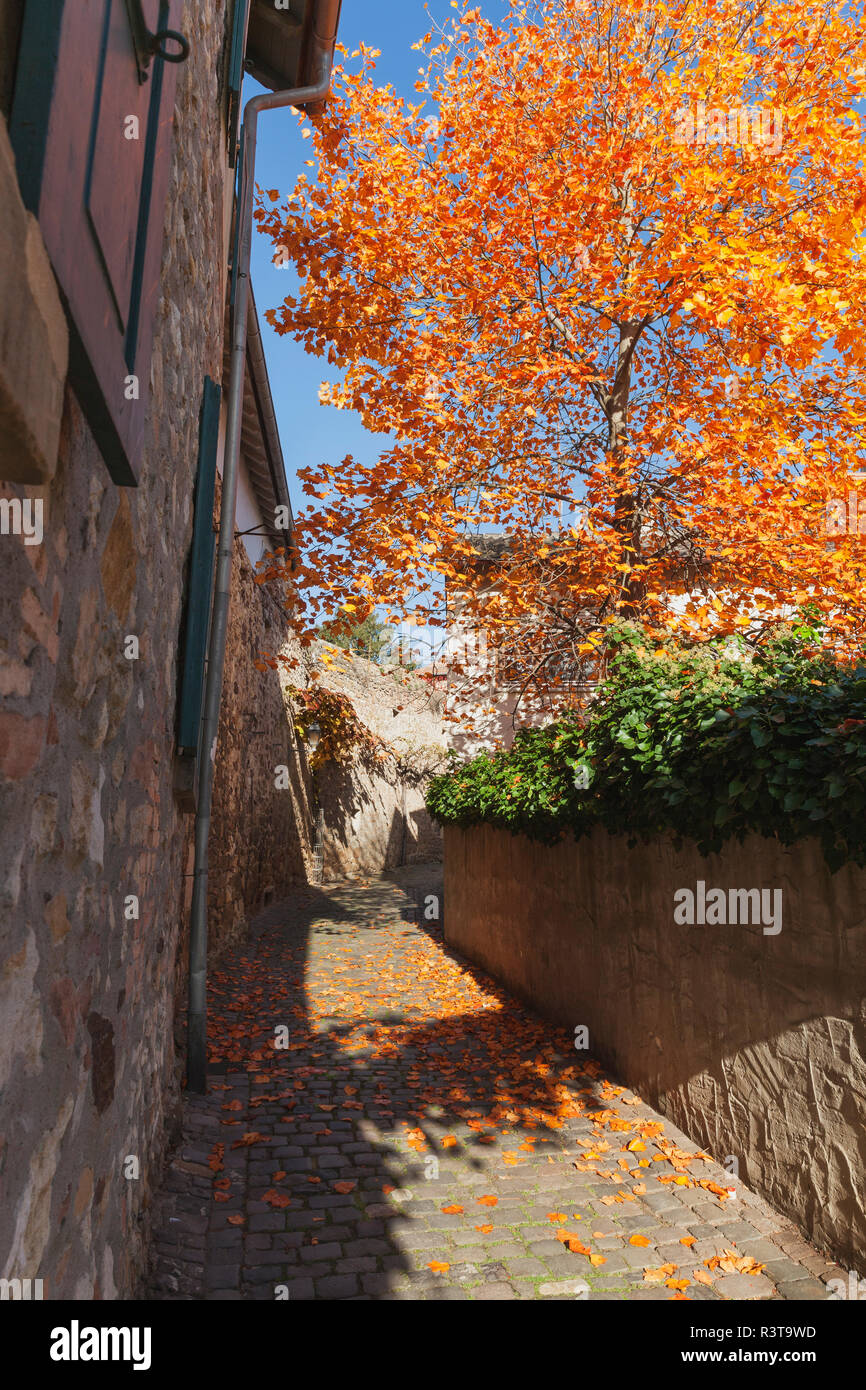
top-left (257, 0), bottom-right (866, 717)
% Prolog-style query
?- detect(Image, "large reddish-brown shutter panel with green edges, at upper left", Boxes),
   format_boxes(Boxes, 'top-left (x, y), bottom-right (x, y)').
top-left (10, 0), bottom-right (182, 487)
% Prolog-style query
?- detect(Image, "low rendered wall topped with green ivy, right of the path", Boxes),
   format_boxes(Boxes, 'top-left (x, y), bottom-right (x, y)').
top-left (445, 827), bottom-right (866, 1269)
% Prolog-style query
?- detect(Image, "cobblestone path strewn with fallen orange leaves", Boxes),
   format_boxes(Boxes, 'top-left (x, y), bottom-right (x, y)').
top-left (145, 867), bottom-right (845, 1300)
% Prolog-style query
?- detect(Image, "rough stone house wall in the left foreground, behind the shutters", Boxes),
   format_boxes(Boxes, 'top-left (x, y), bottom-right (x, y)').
top-left (0, 0), bottom-right (227, 1298)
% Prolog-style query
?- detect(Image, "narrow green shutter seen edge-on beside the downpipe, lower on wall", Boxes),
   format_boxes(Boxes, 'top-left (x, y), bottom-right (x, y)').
top-left (178, 377), bottom-right (221, 752)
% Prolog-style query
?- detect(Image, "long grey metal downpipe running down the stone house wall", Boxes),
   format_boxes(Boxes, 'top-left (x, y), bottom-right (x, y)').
top-left (186, 16), bottom-right (339, 1095)
